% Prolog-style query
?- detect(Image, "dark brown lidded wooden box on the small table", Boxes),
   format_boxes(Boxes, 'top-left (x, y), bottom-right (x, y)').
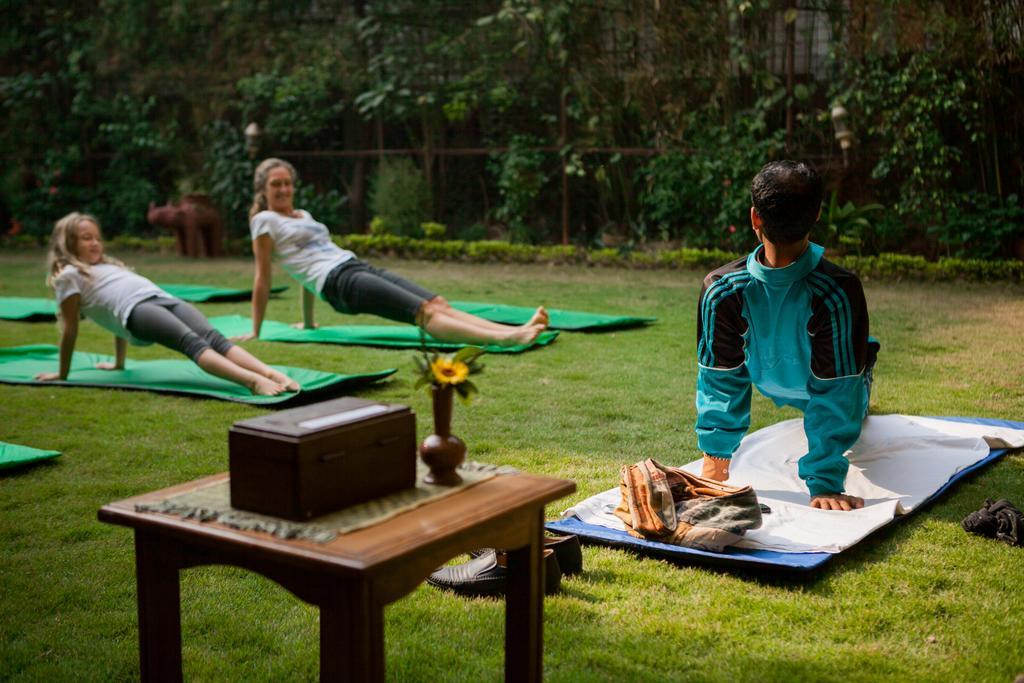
top-left (227, 397), bottom-right (416, 520)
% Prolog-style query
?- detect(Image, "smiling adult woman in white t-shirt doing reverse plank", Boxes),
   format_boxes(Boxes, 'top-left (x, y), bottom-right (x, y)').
top-left (236, 159), bottom-right (548, 346)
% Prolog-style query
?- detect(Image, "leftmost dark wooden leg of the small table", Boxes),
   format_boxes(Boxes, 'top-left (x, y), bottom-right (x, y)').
top-left (135, 529), bottom-right (181, 682)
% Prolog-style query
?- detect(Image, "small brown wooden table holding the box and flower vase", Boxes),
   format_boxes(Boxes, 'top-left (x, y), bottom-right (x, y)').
top-left (99, 473), bottom-right (575, 681)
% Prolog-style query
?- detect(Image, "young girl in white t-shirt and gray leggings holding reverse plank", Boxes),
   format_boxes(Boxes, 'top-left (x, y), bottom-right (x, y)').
top-left (36, 213), bottom-right (299, 396)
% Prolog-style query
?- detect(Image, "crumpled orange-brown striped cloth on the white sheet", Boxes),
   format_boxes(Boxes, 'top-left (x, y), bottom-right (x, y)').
top-left (614, 458), bottom-right (761, 552)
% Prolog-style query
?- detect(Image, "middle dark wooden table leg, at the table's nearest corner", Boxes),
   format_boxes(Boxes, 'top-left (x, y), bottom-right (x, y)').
top-left (319, 581), bottom-right (384, 682)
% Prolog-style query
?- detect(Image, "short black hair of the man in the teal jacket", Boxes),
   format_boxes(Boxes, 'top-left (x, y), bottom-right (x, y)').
top-left (751, 161), bottom-right (822, 245)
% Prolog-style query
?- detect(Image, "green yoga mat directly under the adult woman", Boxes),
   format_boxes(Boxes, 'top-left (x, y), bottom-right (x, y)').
top-left (210, 315), bottom-right (558, 353)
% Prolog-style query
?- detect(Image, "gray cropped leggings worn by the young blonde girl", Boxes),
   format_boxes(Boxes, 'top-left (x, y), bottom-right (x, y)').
top-left (126, 297), bottom-right (234, 362)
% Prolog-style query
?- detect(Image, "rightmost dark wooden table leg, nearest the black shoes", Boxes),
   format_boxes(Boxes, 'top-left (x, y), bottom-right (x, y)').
top-left (505, 508), bottom-right (544, 682)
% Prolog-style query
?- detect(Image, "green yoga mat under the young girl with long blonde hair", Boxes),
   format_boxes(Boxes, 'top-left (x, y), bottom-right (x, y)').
top-left (0, 344), bottom-right (396, 407)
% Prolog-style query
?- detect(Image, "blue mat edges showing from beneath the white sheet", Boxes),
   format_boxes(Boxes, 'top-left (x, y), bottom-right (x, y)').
top-left (545, 417), bottom-right (1024, 571)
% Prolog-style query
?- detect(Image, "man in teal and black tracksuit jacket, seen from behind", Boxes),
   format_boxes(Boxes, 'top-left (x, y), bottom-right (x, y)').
top-left (696, 161), bottom-right (878, 510)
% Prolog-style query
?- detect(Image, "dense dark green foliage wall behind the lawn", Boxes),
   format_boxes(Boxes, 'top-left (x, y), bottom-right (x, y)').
top-left (0, 0), bottom-right (1024, 258)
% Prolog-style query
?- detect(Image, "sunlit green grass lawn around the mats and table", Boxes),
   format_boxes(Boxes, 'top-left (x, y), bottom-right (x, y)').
top-left (0, 252), bottom-right (1024, 683)
